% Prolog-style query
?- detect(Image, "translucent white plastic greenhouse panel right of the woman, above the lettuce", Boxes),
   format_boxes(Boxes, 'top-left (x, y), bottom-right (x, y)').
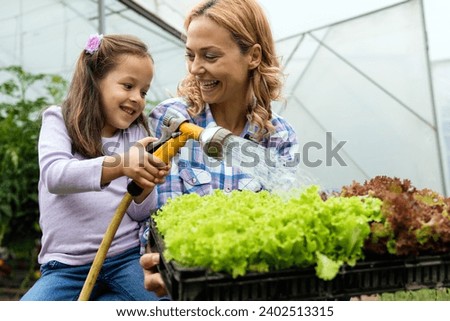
top-left (278, 1), bottom-right (445, 192)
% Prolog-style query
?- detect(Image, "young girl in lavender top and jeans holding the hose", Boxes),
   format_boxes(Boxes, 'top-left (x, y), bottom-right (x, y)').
top-left (22, 35), bottom-right (169, 301)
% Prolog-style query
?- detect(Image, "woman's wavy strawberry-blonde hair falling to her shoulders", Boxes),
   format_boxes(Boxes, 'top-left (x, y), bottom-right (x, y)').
top-left (178, 0), bottom-right (283, 139)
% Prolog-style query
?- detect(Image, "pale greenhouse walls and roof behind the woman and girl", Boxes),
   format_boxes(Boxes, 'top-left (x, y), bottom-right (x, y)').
top-left (0, 0), bottom-right (450, 196)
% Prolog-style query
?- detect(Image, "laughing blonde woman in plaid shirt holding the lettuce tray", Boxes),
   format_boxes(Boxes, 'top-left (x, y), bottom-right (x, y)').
top-left (141, 0), bottom-right (297, 295)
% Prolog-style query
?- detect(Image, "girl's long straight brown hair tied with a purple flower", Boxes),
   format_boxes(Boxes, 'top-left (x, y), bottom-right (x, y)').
top-left (62, 35), bottom-right (152, 157)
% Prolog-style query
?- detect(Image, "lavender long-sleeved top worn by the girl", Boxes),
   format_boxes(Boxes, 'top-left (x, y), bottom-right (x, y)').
top-left (35, 106), bottom-right (156, 265)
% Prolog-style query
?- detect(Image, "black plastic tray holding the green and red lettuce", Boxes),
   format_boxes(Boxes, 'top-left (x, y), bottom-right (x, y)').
top-left (150, 220), bottom-right (450, 301)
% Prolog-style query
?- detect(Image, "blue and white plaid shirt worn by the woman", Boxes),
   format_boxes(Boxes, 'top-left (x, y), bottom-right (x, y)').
top-left (149, 98), bottom-right (298, 210)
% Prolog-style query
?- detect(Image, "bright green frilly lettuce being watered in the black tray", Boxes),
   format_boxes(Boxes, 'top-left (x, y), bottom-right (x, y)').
top-left (154, 185), bottom-right (382, 280)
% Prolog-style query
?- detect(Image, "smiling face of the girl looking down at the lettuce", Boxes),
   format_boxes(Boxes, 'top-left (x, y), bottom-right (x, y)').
top-left (99, 55), bottom-right (153, 137)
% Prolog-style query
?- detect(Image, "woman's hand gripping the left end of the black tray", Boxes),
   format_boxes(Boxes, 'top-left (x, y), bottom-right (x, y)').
top-left (140, 253), bottom-right (167, 297)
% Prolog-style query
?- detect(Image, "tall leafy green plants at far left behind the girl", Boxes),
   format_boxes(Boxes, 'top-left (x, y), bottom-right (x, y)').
top-left (0, 66), bottom-right (67, 259)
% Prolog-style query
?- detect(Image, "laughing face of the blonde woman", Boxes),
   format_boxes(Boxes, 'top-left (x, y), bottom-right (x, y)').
top-left (186, 16), bottom-right (251, 106)
